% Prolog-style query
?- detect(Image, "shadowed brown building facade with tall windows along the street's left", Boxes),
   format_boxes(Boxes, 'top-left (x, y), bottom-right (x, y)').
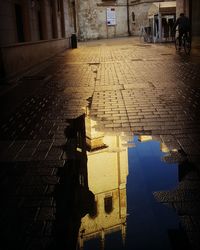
top-left (0, 0), bottom-right (75, 79)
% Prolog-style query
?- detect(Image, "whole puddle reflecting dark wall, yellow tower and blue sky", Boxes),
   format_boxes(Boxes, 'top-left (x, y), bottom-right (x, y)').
top-left (55, 116), bottom-right (192, 250)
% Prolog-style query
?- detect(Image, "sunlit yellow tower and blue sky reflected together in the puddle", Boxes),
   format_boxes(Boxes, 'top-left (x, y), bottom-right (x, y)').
top-left (74, 117), bottom-right (189, 250)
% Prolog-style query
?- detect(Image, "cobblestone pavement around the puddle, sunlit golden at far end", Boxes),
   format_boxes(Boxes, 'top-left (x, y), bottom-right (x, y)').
top-left (0, 38), bottom-right (200, 250)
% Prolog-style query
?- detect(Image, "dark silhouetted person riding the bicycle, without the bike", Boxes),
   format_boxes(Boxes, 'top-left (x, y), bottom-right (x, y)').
top-left (173, 13), bottom-right (190, 49)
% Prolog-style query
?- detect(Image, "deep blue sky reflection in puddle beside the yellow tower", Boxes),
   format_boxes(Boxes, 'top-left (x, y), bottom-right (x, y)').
top-left (127, 137), bottom-right (179, 250)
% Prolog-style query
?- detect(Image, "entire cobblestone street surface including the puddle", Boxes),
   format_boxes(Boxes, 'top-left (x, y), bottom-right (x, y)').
top-left (0, 37), bottom-right (200, 250)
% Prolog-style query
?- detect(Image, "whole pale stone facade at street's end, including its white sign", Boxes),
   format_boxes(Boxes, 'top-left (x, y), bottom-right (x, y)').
top-left (76, 0), bottom-right (177, 40)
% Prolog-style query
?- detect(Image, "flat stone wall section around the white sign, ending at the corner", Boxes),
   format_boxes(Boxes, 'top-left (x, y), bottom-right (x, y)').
top-left (77, 0), bottom-right (128, 40)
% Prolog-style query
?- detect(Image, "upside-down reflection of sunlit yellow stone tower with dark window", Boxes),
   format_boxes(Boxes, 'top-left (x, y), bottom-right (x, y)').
top-left (78, 116), bottom-right (129, 249)
